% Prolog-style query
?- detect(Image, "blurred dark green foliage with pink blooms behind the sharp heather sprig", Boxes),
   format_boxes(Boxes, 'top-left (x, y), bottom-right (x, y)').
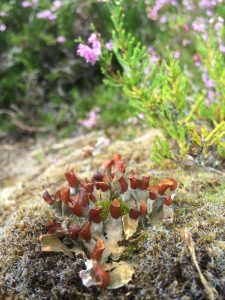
top-left (0, 0), bottom-right (225, 136)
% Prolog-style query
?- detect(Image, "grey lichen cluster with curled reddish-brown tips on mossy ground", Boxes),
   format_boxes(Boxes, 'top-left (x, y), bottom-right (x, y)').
top-left (41, 155), bottom-right (177, 288)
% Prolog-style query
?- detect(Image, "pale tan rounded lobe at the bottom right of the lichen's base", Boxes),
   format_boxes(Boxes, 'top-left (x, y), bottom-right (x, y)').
top-left (105, 261), bottom-right (134, 289)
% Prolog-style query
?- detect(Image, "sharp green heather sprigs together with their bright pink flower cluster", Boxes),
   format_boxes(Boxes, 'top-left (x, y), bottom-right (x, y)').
top-left (77, 1), bottom-right (224, 162)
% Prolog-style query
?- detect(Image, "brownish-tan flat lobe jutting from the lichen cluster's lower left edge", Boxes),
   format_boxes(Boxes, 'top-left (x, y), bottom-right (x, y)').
top-left (40, 234), bottom-right (73, 257)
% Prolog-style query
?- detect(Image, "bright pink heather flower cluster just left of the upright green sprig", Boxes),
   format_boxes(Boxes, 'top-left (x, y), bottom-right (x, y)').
top-left (77, 33), bottom-right (101, 66)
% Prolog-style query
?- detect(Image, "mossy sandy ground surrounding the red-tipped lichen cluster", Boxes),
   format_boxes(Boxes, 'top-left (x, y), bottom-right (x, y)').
top-left (0, 130), bottom-right (225, 299)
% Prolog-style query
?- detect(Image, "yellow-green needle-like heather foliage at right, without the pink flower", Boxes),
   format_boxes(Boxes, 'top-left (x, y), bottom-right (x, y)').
top-left (101, 0), bottom-right (225, 161)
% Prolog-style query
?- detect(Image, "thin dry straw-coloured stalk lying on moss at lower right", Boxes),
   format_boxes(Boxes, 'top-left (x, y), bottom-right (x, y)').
top-left (180, 228), bottom-right (216, 300)
